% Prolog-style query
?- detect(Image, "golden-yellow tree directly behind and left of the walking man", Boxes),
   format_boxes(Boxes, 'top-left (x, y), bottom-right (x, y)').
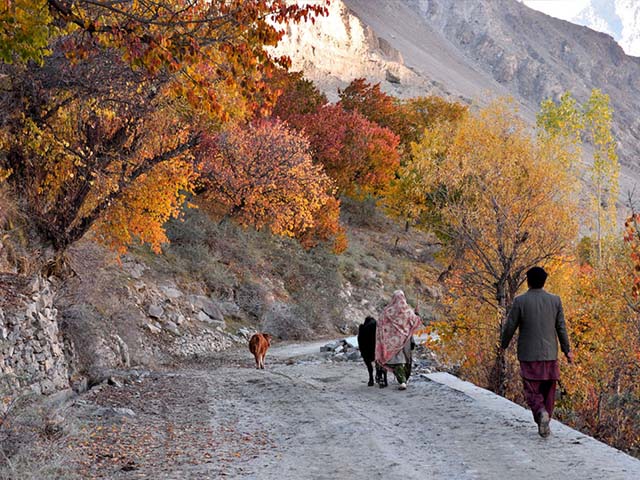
top-left (420, 103), bottom-right (577, 393)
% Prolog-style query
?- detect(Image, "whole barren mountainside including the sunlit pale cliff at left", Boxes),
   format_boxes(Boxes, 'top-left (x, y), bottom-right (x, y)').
top-left (280, 0), bottom-right (640, 196)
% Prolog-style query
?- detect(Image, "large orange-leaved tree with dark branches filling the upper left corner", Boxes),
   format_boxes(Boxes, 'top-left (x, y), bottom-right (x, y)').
top-left (0, 0), bottom-right (326, 255)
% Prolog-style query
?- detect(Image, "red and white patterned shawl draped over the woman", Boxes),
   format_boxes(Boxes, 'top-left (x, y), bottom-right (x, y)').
top-left (376, 290), bottom-right (421, 365)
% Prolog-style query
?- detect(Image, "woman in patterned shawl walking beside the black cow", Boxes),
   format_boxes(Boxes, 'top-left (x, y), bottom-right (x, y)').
top-left (376, 290), bottom-right (422, 390)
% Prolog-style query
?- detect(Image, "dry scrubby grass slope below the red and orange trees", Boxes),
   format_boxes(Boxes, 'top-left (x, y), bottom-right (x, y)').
top-left (154, 200), bottom-right (444, 339)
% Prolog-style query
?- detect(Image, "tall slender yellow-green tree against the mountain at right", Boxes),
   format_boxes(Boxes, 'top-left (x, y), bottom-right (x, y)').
top-left (537, 89), bottom-right (620, 266)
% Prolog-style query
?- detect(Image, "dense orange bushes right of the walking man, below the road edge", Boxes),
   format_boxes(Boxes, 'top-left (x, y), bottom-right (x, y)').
top-left (551, 255), bottom-right (640, 453)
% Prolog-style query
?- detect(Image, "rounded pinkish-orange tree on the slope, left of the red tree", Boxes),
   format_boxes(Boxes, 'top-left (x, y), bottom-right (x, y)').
top-left (199, 120), bottom-right (341, 251)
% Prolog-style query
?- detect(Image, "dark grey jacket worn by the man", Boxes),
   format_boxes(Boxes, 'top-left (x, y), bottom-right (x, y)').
top-left (502, 288), bottom-right (570, 362)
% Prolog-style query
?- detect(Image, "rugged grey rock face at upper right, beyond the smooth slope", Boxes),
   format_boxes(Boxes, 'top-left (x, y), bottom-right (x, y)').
top-left (392, 0), bottom-right (640, 188)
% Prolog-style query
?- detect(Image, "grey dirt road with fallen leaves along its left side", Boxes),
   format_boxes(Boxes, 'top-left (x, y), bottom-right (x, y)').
top-left (55, 344), bottom-right (640, 480)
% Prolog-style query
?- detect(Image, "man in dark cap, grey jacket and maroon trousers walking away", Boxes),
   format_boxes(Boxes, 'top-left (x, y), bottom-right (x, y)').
top-left (501, 267), bottom-right (573, 437)
